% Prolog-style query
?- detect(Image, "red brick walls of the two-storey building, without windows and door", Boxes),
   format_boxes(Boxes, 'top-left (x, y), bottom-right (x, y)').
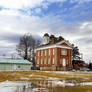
top-left (36, 48), bottom-right (72, 66)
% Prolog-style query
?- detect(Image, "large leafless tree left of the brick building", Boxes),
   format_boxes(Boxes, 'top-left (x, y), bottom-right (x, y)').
top-left (16, 33), bottom-right (40, 64)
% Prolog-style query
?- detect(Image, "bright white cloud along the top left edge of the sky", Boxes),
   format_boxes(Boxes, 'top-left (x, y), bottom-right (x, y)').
top-left (0, 0), bottom-right (43, 9)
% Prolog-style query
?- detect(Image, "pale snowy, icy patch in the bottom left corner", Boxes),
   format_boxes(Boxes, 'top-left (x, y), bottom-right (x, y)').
top-left (0, 81), bottom-right (31, 92)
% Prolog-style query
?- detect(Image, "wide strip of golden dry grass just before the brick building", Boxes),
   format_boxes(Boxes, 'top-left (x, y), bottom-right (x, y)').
top-left (0, 71), bottom-right (92, 82)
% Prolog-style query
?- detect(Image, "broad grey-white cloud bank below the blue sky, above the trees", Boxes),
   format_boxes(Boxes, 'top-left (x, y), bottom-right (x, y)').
top-left (0, 7), bottom-right (92, 60)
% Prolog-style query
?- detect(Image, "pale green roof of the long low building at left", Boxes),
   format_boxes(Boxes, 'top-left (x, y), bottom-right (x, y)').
top-left (0, 58), bottom-right (32, 64)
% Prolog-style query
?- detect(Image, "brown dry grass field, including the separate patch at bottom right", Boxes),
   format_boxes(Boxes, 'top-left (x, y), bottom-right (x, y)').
top-left (0, 71), bottom-right (92, 92)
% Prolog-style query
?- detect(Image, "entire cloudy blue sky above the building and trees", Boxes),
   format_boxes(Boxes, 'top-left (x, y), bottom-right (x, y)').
top-left (0, 0), bottom-right (92, 62)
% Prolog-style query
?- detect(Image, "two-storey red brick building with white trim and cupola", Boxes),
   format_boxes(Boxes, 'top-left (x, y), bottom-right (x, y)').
top-left (36, 33), bottom-right (72, 71)
